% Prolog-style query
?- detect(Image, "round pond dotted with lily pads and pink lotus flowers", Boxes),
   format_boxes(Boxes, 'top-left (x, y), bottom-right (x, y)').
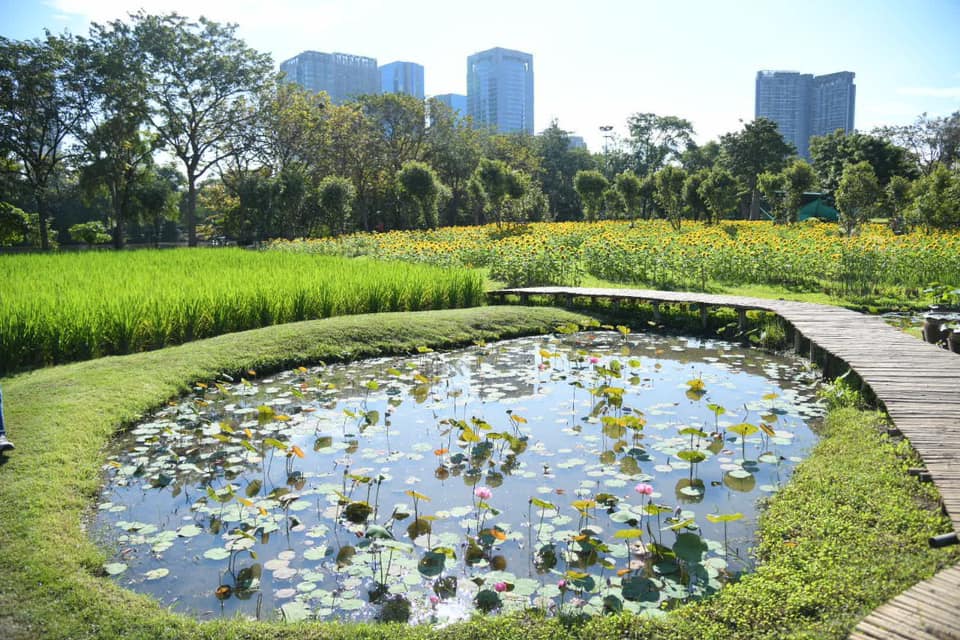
top-left (92, 328), bottom-right (821, 622)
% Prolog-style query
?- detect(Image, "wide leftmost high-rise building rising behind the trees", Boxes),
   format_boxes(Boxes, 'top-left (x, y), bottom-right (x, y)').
top-left (280, 51), bottom-right (380, 104)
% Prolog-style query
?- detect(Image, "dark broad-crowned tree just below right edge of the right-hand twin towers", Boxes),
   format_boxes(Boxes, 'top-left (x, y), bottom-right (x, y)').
top-left (810, 129), bottom-right (917, 198)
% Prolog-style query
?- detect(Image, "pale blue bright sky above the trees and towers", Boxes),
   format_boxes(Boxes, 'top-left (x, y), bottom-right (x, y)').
top-left (0, 0), bottom-right (960, 151)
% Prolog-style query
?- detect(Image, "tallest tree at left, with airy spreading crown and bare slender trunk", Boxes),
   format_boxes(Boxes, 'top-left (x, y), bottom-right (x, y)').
top-left (133, 11), bottom-right (273, 246)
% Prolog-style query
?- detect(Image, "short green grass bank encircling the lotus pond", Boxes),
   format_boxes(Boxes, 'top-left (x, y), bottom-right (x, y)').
top-left (0, 307), bottom-right (958, 640)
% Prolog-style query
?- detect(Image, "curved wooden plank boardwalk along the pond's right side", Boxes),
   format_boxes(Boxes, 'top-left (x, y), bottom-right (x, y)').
top-left (489, 287), bottom-right (960, 640)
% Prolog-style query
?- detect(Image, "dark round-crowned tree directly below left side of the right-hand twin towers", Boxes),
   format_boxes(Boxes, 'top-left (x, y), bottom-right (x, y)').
top-left (720, 118), bottom-right (796, 220)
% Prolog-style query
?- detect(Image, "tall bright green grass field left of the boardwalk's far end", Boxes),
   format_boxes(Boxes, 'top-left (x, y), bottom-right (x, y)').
top-left (0, 249), bottom-right (483, 376)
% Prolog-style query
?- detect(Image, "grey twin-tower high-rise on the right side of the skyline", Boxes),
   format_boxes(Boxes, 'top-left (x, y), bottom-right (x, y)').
top-left (754, 71), bottom-right (857, 159)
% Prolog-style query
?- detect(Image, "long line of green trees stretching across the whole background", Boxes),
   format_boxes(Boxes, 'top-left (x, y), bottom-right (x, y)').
top-left (0, 12), bottom-right (960, 249)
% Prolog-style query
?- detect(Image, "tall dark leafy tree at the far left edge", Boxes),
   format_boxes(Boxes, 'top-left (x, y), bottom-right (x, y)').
top-left (0, 33), bottom-right (80, 250)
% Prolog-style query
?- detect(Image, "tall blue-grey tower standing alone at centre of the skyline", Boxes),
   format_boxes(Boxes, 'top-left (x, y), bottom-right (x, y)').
top-left (467, 47), bottom-right (533, 134)
